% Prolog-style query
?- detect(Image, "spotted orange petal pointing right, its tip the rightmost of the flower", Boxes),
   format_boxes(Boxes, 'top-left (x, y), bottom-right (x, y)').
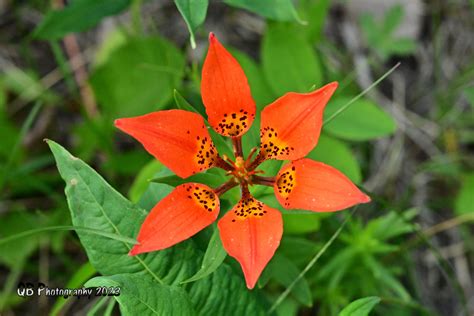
top-left (274, 158), bottom-right (370, 212)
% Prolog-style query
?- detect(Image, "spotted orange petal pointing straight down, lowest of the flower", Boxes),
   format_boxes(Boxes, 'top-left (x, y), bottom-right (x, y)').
top-left (218, 197), bottom-right (283, 289)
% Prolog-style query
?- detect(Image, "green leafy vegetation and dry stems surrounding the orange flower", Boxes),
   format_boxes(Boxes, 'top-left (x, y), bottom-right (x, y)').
top-left (0, 0), bottom-right (474, 315)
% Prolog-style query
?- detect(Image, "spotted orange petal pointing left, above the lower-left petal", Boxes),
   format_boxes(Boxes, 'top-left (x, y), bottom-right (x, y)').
top-left (115, 110), bottom-right (218, 178)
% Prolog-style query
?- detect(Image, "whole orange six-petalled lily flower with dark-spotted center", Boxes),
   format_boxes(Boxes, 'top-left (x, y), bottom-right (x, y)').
top-left (115, 33), bottom-right (370, 289)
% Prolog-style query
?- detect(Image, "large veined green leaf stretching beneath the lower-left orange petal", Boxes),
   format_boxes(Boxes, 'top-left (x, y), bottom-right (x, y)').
top-left (48, 141), bottom-right (264, 315)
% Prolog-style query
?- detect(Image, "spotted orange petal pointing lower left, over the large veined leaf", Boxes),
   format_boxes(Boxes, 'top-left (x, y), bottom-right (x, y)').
top-left (129, 183), bottom-right (220, 256)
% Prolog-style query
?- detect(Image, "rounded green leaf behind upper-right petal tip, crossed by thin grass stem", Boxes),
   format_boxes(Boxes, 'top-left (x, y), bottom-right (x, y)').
top-left (324, 97), bottom-right (396, 141)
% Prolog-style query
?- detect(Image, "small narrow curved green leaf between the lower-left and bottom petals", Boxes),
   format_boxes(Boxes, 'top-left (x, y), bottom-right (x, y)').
top-left (181, 228), bottom-right (227, 283)
